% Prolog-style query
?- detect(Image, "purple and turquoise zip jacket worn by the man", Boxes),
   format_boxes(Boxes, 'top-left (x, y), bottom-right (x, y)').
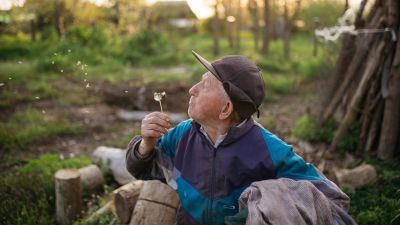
top-left (126, 119), bottom-right (342, 225)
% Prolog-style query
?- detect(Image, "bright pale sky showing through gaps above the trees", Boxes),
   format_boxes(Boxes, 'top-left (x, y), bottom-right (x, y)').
top-left (0, 0), bottom-right (361, 19)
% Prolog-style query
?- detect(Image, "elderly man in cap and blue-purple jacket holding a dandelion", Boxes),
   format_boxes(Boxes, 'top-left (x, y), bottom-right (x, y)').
top-left (126, 51), bottom-right (354, 224)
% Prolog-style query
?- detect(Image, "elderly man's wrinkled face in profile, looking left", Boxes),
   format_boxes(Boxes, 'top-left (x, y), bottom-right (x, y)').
top-left (188, 72), bottom-right (224, 124)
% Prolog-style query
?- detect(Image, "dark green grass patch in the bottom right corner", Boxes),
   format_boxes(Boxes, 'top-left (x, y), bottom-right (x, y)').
top-left (347, 159), bottom-right (400, 225)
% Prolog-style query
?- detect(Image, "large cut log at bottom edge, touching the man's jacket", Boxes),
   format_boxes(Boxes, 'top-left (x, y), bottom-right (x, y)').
top-left (130, 181), bottom-right (179, 225)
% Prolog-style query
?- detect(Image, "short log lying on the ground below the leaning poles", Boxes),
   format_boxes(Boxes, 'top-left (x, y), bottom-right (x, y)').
top-left (335, 164), bottom-right (377, 189)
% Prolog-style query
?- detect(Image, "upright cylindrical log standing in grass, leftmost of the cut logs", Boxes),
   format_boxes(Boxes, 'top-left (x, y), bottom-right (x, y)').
top-left (54, 169), bottom-right (82, 225)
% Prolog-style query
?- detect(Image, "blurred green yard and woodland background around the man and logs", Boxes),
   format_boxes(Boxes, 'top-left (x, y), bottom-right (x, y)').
top-left (0, 0), bottom-right (400, 225)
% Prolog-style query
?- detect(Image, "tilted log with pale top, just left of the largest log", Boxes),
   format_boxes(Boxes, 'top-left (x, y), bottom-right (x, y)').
top-left (113, 180), bottom-right (143, 224)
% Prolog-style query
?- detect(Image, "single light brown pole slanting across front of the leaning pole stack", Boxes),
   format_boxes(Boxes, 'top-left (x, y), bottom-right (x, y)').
top-left (329, 41), bottom-right (385, 151)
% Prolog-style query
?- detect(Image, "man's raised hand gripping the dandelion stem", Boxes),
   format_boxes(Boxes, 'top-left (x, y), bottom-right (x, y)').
top-left (139, 112), bottom-right (171, 156)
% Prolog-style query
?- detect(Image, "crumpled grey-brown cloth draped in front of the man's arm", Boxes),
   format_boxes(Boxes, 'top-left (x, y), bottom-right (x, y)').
top-left (225, 178), bottom-right (356, 225)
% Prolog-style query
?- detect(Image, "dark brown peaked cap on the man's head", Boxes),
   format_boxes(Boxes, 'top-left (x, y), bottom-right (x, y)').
top-left (192, 50), bottom-right (265, 118)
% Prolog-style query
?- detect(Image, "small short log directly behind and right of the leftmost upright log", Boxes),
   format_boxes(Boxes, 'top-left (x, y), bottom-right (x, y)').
top-left (79, 165), bottom-right (104, 192)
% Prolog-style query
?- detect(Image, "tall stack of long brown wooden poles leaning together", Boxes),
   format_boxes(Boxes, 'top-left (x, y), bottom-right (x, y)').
top-left (319, 0), bottom-right (400, 160)
